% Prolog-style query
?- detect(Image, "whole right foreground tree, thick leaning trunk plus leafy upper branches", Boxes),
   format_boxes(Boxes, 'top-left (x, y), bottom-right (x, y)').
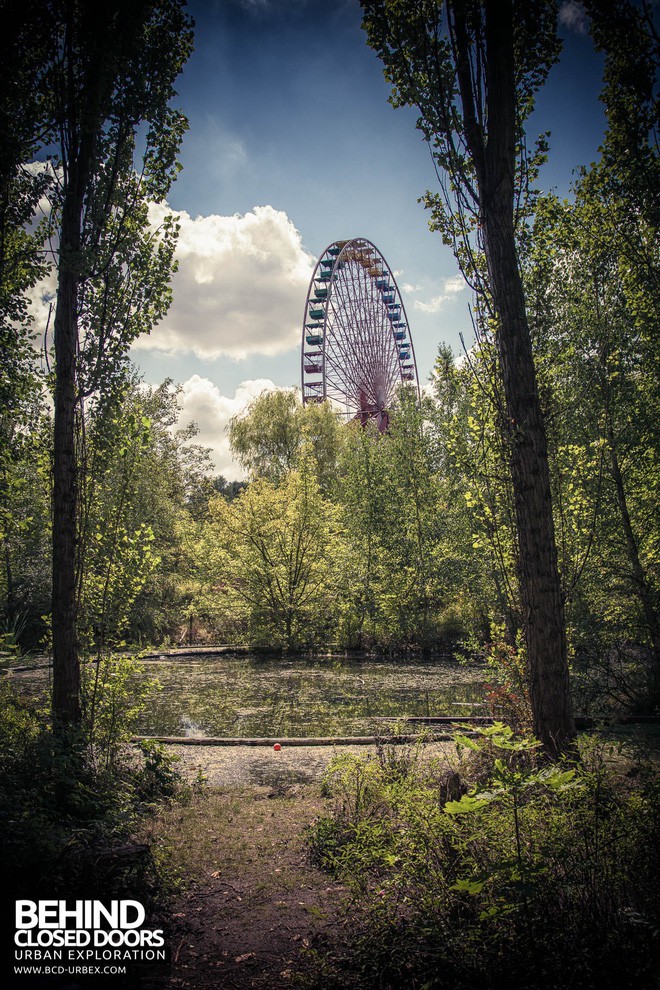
top-left (363, 0), bottom-right (575, 755)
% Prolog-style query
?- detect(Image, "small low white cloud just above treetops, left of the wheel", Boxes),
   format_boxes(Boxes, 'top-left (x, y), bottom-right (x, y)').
top-left (179, 375), bottom-right (276, 481)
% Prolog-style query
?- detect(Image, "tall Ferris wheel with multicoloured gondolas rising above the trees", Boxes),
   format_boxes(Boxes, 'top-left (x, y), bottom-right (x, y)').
top-left (301, 237), bottom-right (419, 432)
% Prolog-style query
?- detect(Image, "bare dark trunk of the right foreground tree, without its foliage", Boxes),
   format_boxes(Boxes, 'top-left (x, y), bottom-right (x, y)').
top-left (479, 0), bottom-right (575, 755)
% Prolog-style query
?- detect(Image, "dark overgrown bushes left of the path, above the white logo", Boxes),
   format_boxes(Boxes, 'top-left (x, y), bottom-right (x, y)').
top-left (0, 659), bottom-right (185, 932)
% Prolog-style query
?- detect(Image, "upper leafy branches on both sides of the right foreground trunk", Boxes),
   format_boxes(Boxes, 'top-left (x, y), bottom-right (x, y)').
top-left (362, 0), bottom-right (561, 299)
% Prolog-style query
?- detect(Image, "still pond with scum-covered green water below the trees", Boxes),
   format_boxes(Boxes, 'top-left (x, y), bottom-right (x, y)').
top-left (139, 654), bottom-right (484, 738)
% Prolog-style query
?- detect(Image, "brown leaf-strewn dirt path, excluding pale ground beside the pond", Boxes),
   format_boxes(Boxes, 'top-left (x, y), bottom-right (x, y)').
top-left (147, 786), bottom-right (347, 990)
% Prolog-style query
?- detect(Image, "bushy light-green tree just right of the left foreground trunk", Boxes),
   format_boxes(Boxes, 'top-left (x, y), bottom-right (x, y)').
top-left (78, 372), bottom-right (213, 658)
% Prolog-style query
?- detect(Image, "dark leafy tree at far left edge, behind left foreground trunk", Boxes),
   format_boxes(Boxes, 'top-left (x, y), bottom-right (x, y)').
top-left (0, 0), bottom-right (50, 646)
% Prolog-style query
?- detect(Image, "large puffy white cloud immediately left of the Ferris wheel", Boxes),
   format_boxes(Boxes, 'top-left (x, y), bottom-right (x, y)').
top-left (134, 205), bottom-right (313, 360)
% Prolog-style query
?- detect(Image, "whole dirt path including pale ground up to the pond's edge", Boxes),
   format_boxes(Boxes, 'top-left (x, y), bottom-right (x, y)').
top-left (145, 743), bottom-right (456, 990)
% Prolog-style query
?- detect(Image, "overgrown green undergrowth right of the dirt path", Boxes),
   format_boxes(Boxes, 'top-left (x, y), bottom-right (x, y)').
top-left (308, 723), bottom-right (660, 990)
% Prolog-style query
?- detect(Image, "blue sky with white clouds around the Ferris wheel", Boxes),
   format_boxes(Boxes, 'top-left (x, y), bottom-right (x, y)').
top-left (126, 0), bottom-right (605, 479)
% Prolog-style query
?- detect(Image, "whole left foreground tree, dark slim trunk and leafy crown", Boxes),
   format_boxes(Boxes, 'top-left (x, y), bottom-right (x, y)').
top-left (44, 0), bottom-right (192, 723)
